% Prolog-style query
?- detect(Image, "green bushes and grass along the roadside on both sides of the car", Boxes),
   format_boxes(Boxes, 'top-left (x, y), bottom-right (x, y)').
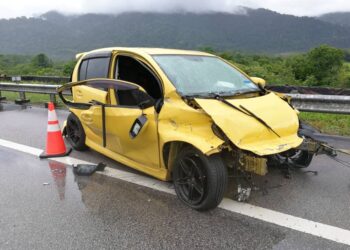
top-left (0, 45), bottom-right (350, 135)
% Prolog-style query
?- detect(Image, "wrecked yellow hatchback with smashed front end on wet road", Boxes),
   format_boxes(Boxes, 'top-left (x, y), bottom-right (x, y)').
top-left (59, 48), bottom-right (313, 210)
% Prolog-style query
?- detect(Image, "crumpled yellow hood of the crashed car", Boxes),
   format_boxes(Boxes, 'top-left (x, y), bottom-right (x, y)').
top-left (195, 93), bottom-right (303, 156)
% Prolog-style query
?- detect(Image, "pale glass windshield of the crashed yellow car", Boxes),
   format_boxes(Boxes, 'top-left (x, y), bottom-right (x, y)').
top-left (153, 55), bottom-right (259, 95)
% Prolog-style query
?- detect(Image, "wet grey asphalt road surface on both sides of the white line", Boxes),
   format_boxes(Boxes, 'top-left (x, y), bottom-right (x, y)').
top-left (0, 101), bottom-right (350, 249)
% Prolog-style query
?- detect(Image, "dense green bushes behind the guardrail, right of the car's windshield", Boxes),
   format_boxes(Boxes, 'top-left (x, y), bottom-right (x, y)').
top-left (203, 45), bottom-right (350, 88)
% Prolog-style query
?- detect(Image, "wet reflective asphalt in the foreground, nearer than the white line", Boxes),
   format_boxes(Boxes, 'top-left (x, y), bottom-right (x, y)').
top-left (0, 148), bottom-right (348, 249)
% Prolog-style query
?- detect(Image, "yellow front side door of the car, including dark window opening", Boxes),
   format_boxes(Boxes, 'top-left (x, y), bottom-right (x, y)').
top-left (102, 54), bottom-right (162, 168)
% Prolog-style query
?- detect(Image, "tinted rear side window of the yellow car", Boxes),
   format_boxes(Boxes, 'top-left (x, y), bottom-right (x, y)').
top-left (79, 57), bottom-right (110, 81)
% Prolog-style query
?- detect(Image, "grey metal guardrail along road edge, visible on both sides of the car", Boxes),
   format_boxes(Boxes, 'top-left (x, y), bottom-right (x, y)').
top-left (0, 82), bottom-right (350, 114)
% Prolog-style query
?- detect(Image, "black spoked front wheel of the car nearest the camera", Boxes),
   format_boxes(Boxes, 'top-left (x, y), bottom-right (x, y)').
top-left (173, 147), bottom-right (228, 211)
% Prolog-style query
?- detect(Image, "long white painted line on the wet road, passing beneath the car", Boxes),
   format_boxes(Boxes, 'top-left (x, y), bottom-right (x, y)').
top-left (0, 139), bottom-right (350, 245)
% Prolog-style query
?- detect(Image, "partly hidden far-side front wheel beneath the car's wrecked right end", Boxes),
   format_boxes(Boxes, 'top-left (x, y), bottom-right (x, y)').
top-left (271, 149), bottom-right (314, 168)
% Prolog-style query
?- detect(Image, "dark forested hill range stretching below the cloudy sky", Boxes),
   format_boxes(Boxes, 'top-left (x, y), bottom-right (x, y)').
top-left (0, 9), bottom-right (350, 58)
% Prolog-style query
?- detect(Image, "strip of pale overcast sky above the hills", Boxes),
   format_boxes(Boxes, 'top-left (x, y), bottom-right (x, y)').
top-left (0, 0), bottom-right (350, 18)
